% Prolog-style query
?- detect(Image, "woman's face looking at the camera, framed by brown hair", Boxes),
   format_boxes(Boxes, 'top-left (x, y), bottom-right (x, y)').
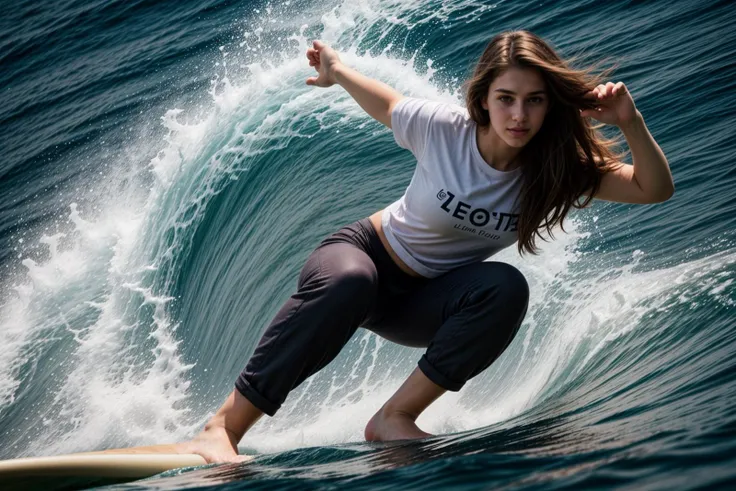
top-left (482, 67), bottom-right (549, 148)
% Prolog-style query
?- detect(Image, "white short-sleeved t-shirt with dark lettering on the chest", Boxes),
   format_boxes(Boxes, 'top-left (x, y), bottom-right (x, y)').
top-left (382, 97), bottom-right (522, 278)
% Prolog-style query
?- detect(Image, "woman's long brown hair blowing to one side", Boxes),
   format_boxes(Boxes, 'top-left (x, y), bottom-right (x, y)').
top-left (465, 31), bottom-right (623, 254)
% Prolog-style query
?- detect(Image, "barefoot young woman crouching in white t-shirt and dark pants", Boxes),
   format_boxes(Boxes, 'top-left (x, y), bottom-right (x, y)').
top-left (175, 31), bottom-right (674, 462)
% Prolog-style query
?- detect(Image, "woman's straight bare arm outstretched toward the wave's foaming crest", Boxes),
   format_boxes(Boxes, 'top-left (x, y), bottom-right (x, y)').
top-left (307, 41), bottom-right (403, 128)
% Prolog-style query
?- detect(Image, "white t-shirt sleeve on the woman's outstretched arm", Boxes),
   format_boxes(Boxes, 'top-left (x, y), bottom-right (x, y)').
top-left (391, 97), bottom-right (443, 160)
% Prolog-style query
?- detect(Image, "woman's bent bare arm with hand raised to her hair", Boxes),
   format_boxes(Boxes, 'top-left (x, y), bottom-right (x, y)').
top-left (581, 82), bottom-right (675, 204)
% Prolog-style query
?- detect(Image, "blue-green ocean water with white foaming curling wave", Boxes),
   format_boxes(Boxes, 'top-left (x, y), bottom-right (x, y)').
top-left (0, 0), bottom-right (736, 490)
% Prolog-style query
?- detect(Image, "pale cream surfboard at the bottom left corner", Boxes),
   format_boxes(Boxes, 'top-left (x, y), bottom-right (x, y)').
top-left (0, 445), bottom-right (207, 491)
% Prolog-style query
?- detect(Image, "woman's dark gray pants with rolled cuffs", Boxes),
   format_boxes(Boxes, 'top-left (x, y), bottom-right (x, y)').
top-left (235, 218), bottom-right (529, 416)
